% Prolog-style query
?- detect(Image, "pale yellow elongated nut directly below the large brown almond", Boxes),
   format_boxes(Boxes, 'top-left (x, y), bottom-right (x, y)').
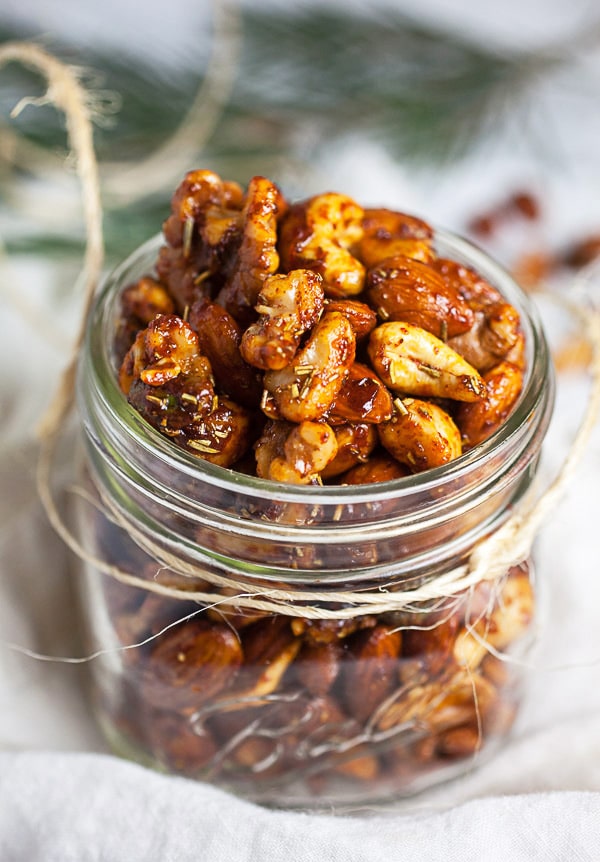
top-left (368, 321), bottom-right (485, 401)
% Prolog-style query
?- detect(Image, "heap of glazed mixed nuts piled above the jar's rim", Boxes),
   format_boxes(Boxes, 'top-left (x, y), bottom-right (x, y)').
top-left (118, 170), bottom-right (523, 484)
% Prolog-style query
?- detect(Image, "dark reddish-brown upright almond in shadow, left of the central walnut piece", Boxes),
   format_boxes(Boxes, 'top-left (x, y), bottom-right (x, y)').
top-left (188, 300), bottom-right (262, 408)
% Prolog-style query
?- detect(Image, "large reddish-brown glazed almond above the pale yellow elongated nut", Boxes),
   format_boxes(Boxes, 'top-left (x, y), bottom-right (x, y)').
top-left (367, 256), bottom-right (475, 341)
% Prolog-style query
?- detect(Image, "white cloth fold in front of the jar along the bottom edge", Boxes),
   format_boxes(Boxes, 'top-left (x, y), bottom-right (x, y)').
top-left (0, 753), bottom-right (600, 862)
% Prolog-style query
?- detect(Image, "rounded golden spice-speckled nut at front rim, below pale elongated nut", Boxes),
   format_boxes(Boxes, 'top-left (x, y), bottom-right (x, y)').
top-left (377, 398), bottom-right (462, 472)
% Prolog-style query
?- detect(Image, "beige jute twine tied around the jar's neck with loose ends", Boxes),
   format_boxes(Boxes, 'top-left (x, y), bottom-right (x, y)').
top-left (0, 43), bottom-right (600, 619)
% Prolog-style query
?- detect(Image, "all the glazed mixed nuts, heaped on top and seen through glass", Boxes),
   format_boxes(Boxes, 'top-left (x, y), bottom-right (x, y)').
top-left (77, 170), bottom-right (556, 799)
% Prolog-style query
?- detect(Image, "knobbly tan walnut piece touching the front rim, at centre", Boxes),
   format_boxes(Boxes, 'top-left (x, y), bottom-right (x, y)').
top-left (255, 421), bottom-right (338, 485)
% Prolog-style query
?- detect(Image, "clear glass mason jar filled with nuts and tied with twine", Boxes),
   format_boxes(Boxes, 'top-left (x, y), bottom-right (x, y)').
top-left (78, 231), bottom-right (553, 807)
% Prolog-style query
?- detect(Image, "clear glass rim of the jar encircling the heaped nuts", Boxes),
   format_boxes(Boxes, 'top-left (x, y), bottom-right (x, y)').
top-left (78, 228), bottom-right (552, 505)
